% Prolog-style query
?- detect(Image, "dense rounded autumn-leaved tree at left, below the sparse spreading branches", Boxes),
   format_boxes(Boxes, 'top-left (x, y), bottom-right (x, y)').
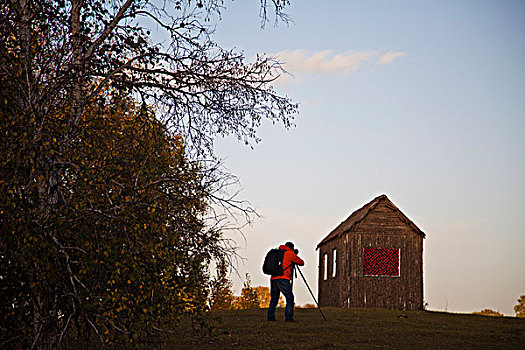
top-left (0, 96), bottom-right (220, 348)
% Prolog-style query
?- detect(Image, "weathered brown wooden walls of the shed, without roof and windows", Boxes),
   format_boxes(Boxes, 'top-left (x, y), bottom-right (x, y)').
top-left (319, 198), bottom-right (423, 310)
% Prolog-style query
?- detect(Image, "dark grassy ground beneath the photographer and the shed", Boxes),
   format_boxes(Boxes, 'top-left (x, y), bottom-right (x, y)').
top-left (169, 309), bottom-right (525, 350)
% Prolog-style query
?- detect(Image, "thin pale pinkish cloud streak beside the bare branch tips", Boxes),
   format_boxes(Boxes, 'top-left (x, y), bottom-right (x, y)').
top-left (274, 50), bottom-right (406, 83)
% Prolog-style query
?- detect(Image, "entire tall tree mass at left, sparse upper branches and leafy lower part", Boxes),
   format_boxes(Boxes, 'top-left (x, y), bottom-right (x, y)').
top-left (0, 0), bottom-right (297, 348)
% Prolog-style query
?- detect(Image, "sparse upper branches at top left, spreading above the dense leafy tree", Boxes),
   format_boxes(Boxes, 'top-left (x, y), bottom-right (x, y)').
top-left (0, 0), bottom-right (297, 159)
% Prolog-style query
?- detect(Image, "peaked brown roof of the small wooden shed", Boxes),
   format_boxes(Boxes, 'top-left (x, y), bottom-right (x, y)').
top-left (316, 194), bottom-right (425, 249)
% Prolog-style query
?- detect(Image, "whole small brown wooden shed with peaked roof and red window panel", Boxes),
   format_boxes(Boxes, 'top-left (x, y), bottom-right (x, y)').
top-left (317, 195), bottom-right (425, 310)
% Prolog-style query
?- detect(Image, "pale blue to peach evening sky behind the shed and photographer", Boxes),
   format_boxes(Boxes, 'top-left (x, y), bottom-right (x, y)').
top-left (207, 0), bottom-right (525, 315)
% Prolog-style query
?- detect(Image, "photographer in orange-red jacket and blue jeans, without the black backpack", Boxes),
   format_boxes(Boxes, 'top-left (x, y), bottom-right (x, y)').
top-left (268, 242), bottom-right (304, 322)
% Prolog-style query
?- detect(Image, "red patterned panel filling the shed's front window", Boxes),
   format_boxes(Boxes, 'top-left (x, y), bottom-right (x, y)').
top-left (363, 247), bottom-right (399, 276)
